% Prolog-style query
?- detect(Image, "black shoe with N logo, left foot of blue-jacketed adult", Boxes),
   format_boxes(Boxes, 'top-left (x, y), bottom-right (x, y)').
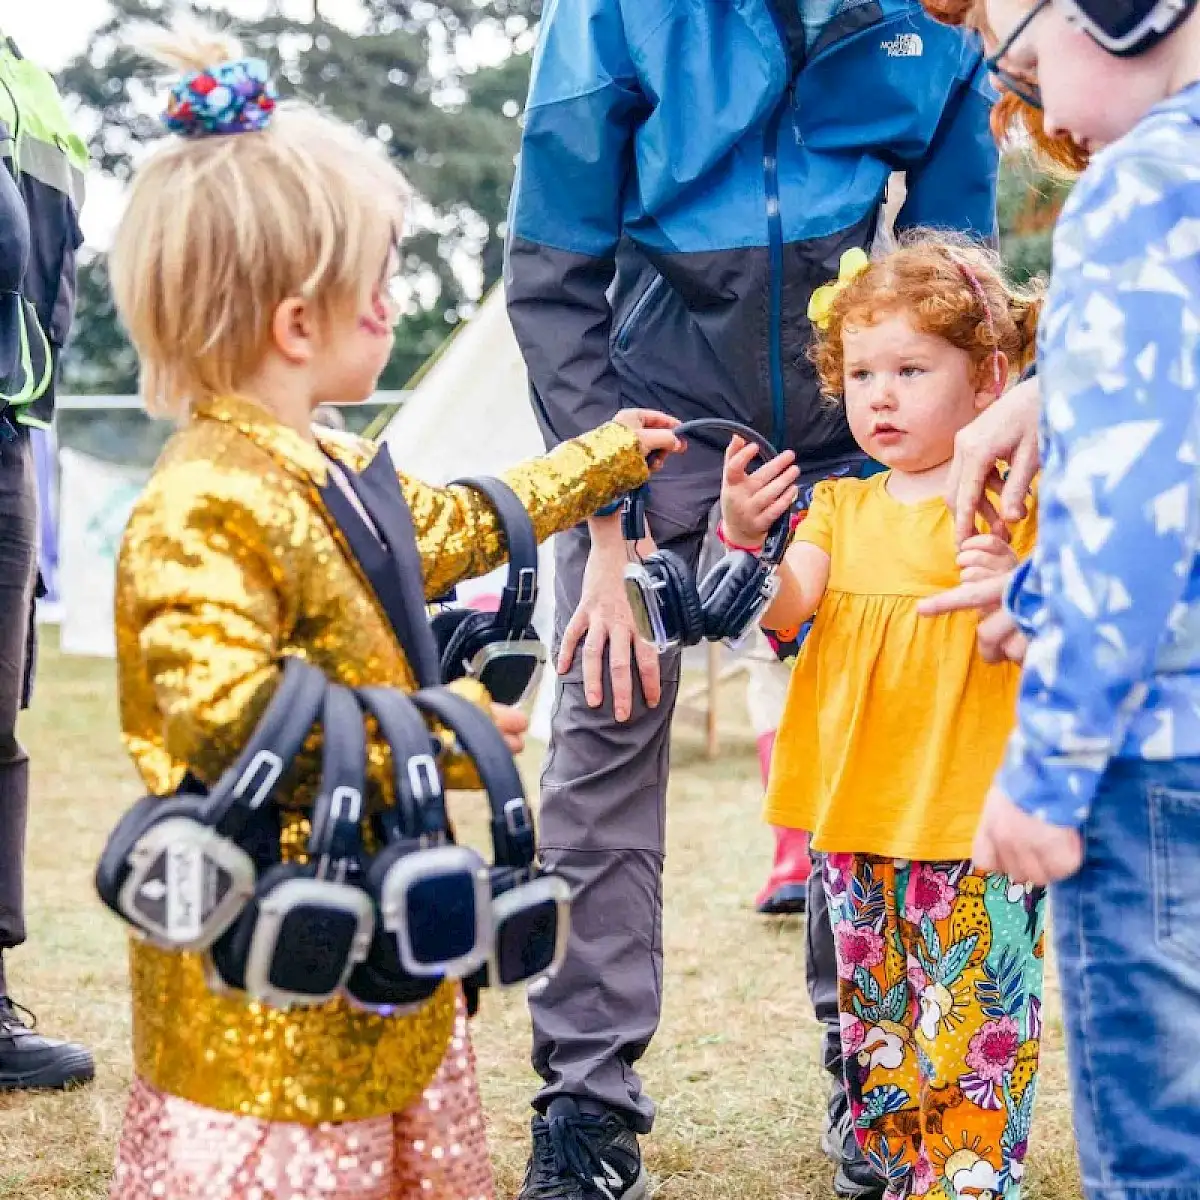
top-left (517, 1096), bottom-right (649, 1200)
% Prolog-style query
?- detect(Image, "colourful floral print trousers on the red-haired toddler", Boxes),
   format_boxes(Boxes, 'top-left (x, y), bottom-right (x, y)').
top-left (826, 854), bottom-right (1045, 1200)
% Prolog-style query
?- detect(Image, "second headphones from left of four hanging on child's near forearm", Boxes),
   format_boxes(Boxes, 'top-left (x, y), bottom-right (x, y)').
top-left (210, 684), bottom-right (374, 1008)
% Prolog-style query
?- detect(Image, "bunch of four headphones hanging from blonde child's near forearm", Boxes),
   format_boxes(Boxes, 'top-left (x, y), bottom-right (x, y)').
top-left (96, 659), bottom-right (570, 1012)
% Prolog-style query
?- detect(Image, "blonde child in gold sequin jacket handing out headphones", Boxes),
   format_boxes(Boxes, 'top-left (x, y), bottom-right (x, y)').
top-left (112, 21), bottom-right (676, 1200)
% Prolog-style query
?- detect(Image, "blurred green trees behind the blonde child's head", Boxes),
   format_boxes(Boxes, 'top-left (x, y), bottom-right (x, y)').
top-left (60, 0), bottom-right (541, 388)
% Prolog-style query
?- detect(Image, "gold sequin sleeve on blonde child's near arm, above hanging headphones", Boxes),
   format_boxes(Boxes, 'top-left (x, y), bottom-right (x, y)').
top-left (118, 463), bottom-right (298, 782)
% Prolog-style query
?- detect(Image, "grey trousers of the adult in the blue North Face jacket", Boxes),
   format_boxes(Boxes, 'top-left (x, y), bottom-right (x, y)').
top-left (529, 470), bottom-right (842, 1133)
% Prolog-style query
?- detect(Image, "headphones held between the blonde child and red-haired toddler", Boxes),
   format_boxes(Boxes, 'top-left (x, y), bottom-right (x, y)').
top-left (620, 418), bottom-right (792, 654)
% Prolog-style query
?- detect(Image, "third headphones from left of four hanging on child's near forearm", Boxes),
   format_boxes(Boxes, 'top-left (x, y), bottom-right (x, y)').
top-left (346, 688), bottom-right (492, 1007)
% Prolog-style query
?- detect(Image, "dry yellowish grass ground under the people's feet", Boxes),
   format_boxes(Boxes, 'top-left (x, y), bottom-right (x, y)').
top-left (0, 633), bottom-right (1080, 1200)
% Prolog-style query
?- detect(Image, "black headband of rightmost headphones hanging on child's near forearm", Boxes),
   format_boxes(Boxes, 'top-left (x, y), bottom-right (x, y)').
top-left (413, 688), bottom-right (535, 869)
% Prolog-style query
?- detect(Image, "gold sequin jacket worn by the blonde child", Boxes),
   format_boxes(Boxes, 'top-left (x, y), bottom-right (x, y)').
top-left (116, 398), bottom-right (646, 1124)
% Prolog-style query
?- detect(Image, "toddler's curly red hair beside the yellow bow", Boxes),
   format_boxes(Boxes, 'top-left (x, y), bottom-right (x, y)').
top-left (809, 230), bottom-right (1045, 400)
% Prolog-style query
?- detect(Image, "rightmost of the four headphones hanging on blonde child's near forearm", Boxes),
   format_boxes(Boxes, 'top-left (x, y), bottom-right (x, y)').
top-left (413, 688), bottom-right (571, 988)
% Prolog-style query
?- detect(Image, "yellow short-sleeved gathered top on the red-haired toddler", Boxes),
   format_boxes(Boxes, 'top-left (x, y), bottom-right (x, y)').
top-left (766, 472), bottom-right (1037, 860)
